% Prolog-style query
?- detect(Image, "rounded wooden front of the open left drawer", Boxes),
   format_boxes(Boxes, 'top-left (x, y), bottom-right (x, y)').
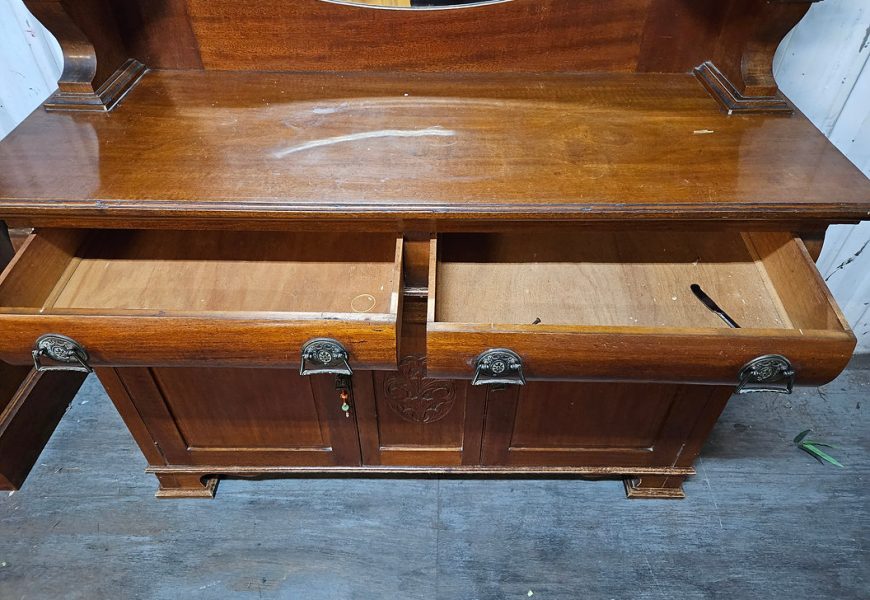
top-left (0, 314), bottom-right (396, 369)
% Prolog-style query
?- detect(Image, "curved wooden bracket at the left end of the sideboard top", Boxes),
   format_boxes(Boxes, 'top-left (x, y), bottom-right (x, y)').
top-left (25, 0), bottom-right (146, 111)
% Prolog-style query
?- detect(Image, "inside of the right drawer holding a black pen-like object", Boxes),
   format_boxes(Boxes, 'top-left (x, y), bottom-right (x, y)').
top-left (429, 231), bottom-right (846, 330)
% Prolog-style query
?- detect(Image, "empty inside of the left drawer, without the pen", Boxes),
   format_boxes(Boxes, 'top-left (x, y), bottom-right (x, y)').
top-left (0, 230), bottom-right (401, 315)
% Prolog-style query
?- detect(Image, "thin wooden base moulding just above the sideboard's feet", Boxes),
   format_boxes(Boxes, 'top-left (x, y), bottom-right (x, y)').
top-left (145, 465), bottom-right (695, 477)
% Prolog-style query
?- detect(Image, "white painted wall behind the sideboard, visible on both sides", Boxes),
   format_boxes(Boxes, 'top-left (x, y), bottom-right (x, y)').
top-left (0, 0), bottom-right (870, 352)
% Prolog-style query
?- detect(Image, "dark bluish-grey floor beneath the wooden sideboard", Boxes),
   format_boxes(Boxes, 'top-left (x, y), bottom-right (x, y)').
top-left (0, 363), bottom-right (870, 600)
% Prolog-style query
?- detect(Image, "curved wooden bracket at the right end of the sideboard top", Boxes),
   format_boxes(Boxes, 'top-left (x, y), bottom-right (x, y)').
top-left (695, 0), bottom-right (820, 114)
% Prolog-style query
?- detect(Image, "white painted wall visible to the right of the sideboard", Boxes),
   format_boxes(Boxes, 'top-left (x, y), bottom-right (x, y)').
top-left (773, 0), bottom-right (870, 353)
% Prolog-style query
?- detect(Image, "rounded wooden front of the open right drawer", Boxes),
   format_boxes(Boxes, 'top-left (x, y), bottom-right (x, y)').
top-left (426, 325), bottom-right (855, 385)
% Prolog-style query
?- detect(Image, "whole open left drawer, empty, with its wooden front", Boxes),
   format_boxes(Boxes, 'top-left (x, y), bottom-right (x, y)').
top-left (0, 230), bottom-right (402, 369)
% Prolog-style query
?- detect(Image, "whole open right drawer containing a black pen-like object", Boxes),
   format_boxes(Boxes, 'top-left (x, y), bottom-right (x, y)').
top-left (426, 231), bottom-right (855, 390)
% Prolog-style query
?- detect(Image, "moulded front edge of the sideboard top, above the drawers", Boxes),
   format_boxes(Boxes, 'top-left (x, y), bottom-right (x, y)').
top-left (0, 196), bottom-right (868, 224)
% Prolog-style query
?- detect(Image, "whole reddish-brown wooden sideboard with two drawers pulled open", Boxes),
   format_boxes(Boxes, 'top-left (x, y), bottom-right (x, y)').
top-left (0, 0), bottom-right (870, 498)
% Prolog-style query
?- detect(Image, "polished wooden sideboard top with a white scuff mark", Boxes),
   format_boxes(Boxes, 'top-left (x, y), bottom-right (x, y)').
top-left (0, 72), bottom-right (870, 226)
